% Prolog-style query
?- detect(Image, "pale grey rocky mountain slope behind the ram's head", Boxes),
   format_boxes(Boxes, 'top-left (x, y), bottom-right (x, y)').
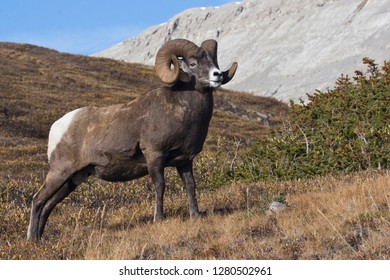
top-left (96, 0), bottom-right (390, 102)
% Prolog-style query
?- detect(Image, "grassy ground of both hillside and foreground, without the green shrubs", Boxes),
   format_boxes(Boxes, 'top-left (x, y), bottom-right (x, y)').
top-left (0, 43), bottom-right (390, 259)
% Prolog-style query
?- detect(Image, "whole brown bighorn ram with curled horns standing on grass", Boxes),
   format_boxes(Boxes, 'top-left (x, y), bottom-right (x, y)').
top-left (27, 39), bottom-right (237, 240)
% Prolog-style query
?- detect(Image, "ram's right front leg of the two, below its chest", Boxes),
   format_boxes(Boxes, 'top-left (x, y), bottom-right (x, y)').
top-left (177, 161), bottom-right (200, 219)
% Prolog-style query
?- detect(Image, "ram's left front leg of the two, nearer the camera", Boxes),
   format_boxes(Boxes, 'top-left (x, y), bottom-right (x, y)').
top-left (147, 153), bottom-right (165, 222)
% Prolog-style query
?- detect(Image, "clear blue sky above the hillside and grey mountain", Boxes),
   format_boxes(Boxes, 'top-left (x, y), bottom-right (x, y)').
top-left (0, 0), bottom-right (232, 55)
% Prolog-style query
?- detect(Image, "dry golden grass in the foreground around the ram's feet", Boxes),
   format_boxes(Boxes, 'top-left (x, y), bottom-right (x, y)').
top-left (11, 168), bottom-right (380, 259)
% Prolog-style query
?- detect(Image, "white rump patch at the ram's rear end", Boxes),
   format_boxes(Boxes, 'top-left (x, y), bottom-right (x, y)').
top-left (47, 109), bottom-right (80, 160)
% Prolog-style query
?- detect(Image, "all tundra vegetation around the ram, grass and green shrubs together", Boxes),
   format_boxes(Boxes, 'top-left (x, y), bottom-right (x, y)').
top-left (0, 43), bottom-right (390, 259)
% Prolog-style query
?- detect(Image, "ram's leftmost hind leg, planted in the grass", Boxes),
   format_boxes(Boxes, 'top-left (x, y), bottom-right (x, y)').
top-left (27, 171), bottom-right (70, 240)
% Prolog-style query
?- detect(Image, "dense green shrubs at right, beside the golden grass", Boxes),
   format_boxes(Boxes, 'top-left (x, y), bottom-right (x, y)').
top-left (237, 58), bottom-right (390, 180)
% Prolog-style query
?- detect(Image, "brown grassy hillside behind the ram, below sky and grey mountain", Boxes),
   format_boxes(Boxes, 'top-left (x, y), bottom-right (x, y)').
top-left (0, 43), bottom-right (287, 177)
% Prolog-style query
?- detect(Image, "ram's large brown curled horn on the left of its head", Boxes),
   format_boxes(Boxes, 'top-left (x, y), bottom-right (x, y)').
top-left (155, 39), bottom-right (201, 84)
